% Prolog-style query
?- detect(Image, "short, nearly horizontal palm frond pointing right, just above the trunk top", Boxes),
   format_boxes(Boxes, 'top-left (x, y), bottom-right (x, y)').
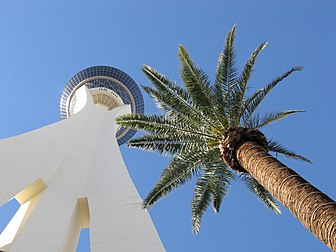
top-left (246, 110), bottom-right (305, 129)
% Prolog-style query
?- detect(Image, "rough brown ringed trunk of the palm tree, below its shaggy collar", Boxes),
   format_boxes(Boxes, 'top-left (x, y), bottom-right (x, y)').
top-left (237, 141), bottom-right (336, 251)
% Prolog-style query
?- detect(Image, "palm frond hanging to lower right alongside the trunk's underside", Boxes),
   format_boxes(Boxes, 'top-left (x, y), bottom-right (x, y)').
top-left (241, 174), bottom-right (281, 214)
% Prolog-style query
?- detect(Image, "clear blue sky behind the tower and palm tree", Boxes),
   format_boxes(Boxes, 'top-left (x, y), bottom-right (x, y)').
top-left (0, 0), bottom-right (336, 252)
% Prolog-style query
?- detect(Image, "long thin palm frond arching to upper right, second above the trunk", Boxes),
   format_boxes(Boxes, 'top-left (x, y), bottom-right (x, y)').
top-left (243, 66), bottom-right (303, 125)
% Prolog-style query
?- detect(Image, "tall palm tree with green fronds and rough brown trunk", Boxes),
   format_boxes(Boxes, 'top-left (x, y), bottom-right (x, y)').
top-left (117, 26), bottom-right (336, 250)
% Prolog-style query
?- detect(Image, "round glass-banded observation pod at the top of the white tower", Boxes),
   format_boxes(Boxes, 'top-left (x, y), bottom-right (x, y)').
top-left (60, 66), bottom-right (144, 145)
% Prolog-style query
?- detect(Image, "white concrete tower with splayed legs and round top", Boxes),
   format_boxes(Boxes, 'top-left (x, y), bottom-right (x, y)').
top-left (0, 66), bottom-right (164, 252)
